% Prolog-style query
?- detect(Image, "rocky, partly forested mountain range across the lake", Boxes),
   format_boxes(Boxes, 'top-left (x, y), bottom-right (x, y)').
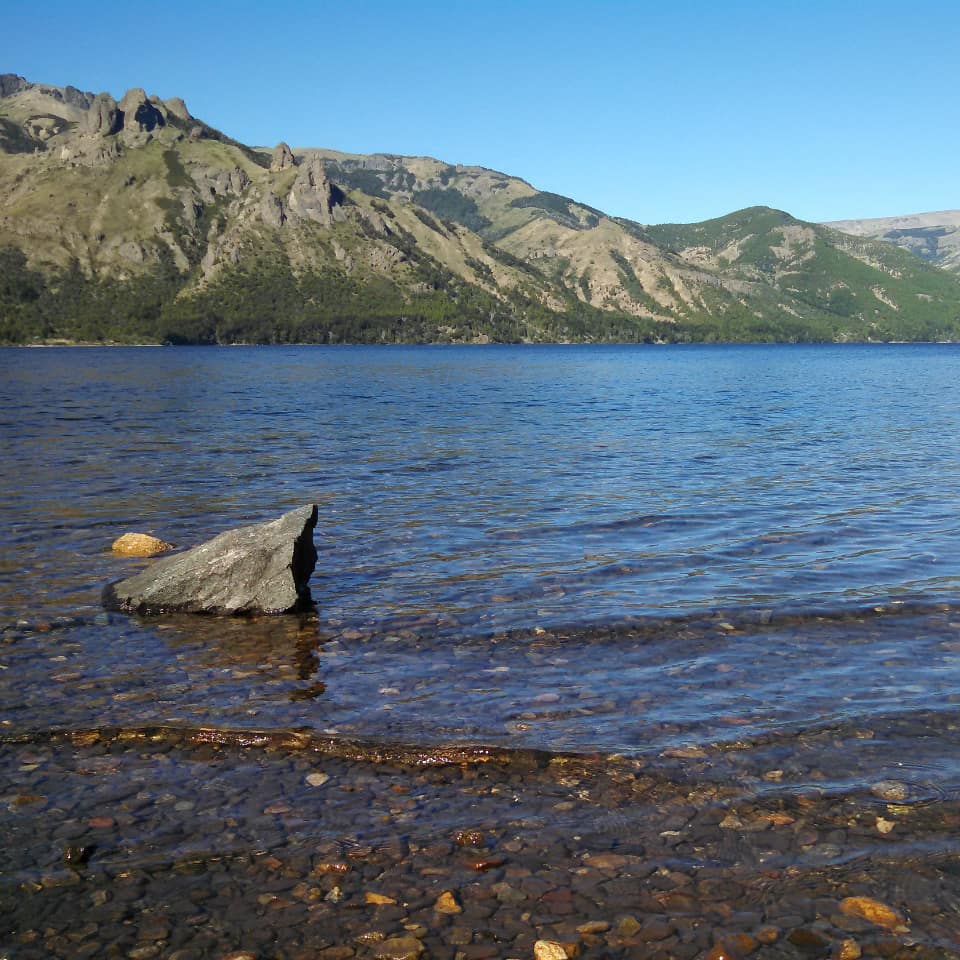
top-left (0, 74), bottom-right (960, 343)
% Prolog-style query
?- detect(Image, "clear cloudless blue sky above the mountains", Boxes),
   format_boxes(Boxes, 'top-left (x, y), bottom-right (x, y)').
top-left (0, 0), bottom-right (960, 223)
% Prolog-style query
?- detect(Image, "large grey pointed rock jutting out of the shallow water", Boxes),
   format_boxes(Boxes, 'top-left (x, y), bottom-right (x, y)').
top-left (103, 504), bottom-right (317, 614)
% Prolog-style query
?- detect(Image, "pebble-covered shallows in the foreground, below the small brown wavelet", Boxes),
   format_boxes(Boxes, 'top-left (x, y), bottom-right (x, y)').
top-left (0, 737), bottom-right (960, 960)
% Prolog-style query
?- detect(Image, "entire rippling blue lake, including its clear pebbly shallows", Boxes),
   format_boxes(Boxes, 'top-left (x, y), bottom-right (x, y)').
top-left (0, 345), bottom-right (960, 960)
